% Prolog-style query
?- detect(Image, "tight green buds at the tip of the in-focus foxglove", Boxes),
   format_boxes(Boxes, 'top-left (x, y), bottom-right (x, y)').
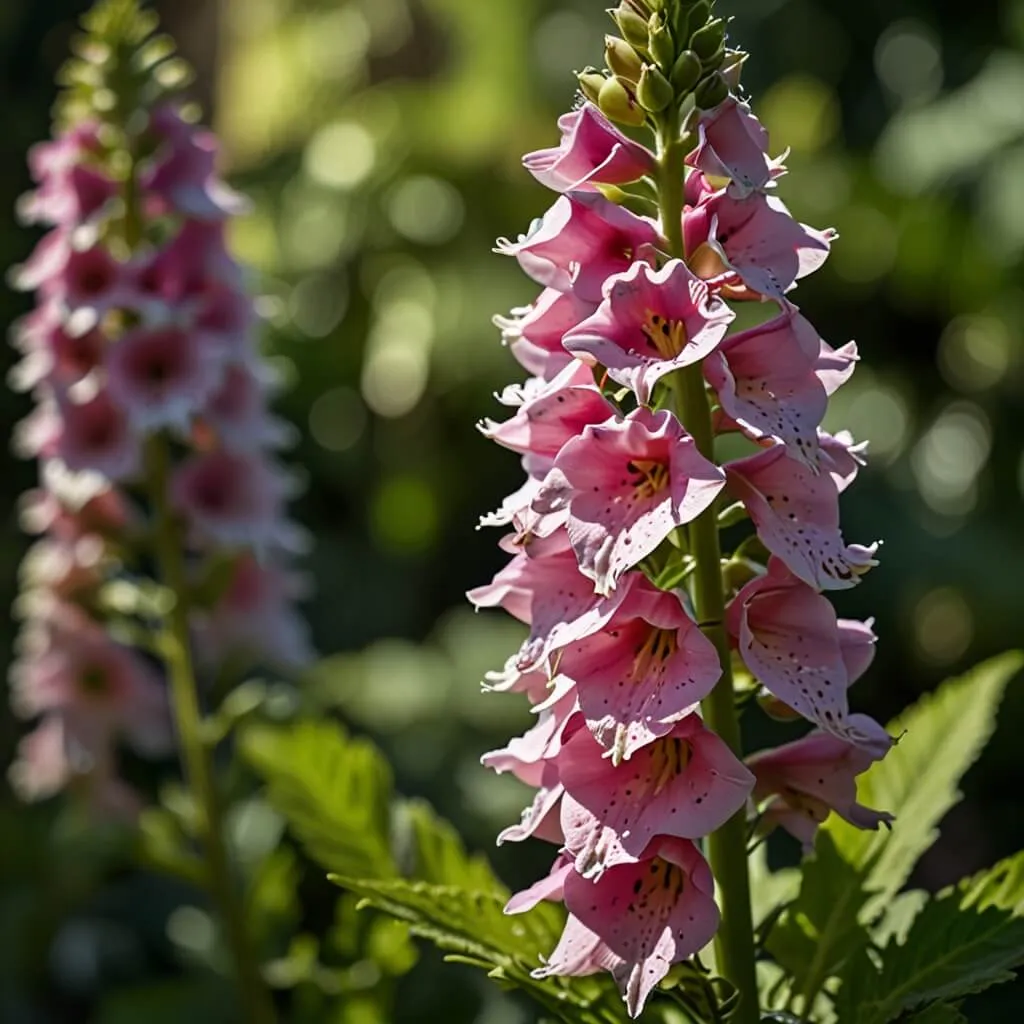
top-left (578, 0), bottom-right (745, 126)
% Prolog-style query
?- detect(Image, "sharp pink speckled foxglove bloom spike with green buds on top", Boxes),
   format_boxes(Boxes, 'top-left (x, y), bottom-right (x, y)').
top-left (470, 0), bottom-right (892, 1016)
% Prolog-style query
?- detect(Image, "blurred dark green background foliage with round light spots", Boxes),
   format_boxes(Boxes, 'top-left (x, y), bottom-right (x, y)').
top-left (0, 0), bottom-right (1024, 1024)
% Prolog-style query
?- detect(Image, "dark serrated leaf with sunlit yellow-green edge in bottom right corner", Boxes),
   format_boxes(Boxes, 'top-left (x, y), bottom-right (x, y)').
top-left (836, 853), bottom-right (1024, 1024)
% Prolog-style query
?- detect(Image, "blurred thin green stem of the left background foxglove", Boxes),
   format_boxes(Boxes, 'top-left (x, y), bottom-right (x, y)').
top-left (124, 151), bottom-right (278, 1024)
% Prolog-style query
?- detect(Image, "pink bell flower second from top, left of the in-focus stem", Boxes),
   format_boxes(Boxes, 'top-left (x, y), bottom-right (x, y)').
top-left (495, 191), bottom-right (659, 303)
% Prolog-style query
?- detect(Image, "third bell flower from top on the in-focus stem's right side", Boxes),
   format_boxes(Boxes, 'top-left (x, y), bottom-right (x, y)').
top-left (703, 305), bottom-right (852, 469)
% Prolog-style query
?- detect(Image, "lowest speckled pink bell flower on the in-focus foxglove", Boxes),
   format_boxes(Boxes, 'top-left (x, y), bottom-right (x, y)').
top-left (520, 839), bottom-right (719, 1018)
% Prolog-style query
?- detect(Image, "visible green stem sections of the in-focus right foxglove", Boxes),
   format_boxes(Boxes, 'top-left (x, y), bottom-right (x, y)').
top-left (657, 130), bottom-right (760, 1024)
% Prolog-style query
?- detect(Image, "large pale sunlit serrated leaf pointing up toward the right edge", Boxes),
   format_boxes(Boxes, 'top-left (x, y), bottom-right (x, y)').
top-left (824, 651), bottom-right (1024, 902)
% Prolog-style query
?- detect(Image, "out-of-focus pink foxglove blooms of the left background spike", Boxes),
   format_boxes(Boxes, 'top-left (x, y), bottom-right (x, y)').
top-left (11, 90), bottom-right (308, 811)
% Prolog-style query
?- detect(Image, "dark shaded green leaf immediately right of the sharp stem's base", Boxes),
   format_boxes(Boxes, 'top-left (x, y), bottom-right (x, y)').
top-left (766, 831), bottom-right (870, 1007)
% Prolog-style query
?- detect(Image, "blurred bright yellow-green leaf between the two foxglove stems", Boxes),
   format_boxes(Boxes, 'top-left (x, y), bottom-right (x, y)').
top-left (240, 721), bottom-right (397, 879)
